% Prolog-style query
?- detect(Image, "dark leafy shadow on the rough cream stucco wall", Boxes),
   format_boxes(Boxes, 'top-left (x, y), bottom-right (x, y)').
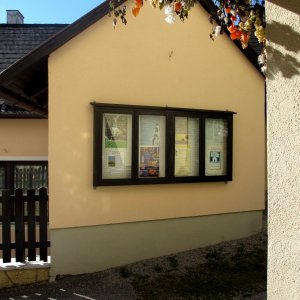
top-left (267, 20), bottom-right (300, 80)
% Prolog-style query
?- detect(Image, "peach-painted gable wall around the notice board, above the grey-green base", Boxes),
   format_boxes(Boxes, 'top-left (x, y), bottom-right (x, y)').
top-left (49, 0), bottom-right (264, 228)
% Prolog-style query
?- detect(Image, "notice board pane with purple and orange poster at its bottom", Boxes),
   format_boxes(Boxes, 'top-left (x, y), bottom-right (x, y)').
top-left (138, 115), bottom-right (166, 178)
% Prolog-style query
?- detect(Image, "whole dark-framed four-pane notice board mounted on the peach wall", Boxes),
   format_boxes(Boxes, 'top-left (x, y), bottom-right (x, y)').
top-left (93, 103), bottom-right (234, 187)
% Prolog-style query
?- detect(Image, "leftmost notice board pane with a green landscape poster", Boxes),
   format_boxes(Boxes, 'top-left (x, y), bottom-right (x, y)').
top-left (102, 113), bottom-right (132, 179)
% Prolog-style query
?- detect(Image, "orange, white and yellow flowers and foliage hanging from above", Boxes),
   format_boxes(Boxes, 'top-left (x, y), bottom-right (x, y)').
top-left (110, 0), bottom-right (266, 73)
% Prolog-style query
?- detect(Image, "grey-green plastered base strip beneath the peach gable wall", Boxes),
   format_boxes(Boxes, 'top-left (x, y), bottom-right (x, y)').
top-left (50, 211), bottom-right (262, 278)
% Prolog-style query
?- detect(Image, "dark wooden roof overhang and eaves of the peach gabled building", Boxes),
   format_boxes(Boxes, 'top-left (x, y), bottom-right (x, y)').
top-left (0, 0), bottom-right (259, 115)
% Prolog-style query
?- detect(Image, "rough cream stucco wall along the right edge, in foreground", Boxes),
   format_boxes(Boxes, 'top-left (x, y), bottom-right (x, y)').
top-left (266, 0), bottom-right (300, 300)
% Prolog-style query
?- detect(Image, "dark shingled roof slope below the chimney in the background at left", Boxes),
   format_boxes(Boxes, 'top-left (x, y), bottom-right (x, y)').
top-left (0, 24), bottom-right (66, 73)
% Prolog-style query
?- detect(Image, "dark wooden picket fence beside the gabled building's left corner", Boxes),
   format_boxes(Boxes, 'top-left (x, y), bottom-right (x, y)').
top-left (0, 188), bottom-right (50, 263)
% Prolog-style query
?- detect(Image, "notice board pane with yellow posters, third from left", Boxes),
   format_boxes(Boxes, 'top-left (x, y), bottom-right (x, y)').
top-left (174, 117), bottom-right (199, 177)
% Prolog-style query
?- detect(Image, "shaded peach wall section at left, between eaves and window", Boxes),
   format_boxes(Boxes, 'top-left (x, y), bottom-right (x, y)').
top-left (0, 119), bottom-right (48, 160)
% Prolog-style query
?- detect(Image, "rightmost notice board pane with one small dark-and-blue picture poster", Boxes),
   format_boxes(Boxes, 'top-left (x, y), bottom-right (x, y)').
top-left (205, 118), bottom-right (228, 176)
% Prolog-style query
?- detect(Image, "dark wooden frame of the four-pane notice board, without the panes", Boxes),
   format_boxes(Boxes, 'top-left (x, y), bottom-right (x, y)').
top-left (91, 102), bottom-right (236, 188)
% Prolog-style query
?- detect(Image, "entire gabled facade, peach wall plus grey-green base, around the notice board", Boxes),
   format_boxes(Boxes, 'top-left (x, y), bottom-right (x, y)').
top-left (49, 1), bottom-right (265, 276)
